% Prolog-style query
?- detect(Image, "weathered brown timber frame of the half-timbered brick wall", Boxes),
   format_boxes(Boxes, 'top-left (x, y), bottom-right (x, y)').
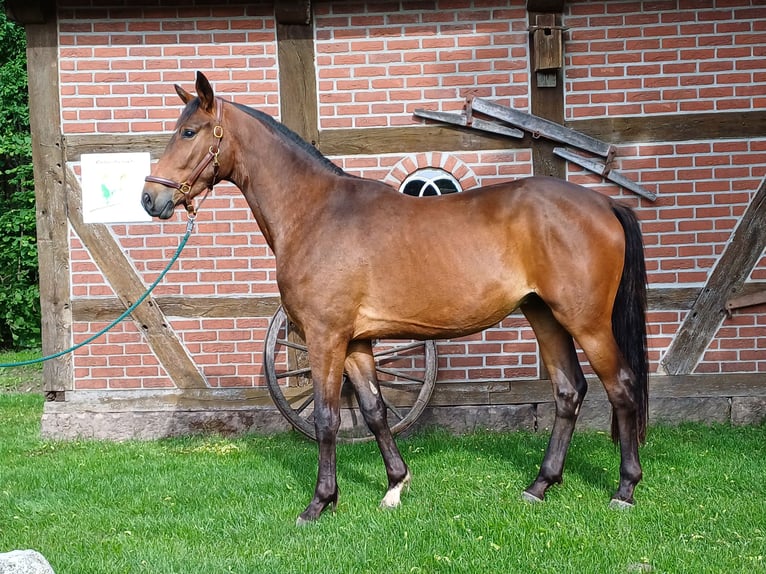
top-left (6, 0), bottom-right (766, 440)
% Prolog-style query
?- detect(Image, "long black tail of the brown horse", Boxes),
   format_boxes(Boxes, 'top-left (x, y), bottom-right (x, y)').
top-left (612, 203), bottom-right (649, 443)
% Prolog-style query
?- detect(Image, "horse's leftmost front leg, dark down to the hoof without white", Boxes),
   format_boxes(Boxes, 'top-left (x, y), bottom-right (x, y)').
top-left (297, 338), bottom-right (346, 524)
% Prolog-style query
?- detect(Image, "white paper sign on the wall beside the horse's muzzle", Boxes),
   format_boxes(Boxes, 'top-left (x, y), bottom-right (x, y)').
top-left (81, 152), bottom-right (152, 223)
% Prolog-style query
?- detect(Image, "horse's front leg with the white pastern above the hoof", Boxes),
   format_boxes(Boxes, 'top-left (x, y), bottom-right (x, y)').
top-left (346, 341), bottom-right (410, 507)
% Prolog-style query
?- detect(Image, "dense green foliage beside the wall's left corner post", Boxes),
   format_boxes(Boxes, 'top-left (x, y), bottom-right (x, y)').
top-left (0, 0), bottom-right (40, 348)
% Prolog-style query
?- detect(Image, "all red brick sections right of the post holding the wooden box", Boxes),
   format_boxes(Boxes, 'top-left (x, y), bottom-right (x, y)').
top-left (564, 0), bottom-right (766, 373)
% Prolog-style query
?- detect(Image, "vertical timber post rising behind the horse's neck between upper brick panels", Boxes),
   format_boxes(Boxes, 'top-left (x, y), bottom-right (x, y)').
top-left (277, 17), bottom-right (319, 145)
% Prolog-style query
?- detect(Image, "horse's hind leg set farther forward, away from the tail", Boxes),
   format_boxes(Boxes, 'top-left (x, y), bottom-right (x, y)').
top-left (521, 297), bottom-right (588, 501)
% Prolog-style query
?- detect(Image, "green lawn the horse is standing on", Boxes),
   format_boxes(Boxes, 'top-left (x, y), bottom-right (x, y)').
top-left (0, 393), bottom-right (766, 574)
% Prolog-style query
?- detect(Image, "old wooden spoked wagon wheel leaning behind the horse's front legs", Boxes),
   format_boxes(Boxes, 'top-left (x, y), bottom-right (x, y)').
top-left (264, 306), bottom-right (436, 442)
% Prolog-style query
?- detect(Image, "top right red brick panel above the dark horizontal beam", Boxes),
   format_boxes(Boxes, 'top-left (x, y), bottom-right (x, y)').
top-left (565, 0), bottom-right (766, 119)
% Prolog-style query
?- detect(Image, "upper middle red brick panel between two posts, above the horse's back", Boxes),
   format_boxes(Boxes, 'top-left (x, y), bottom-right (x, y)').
top-left (314, 0), bottom-right (529, 128)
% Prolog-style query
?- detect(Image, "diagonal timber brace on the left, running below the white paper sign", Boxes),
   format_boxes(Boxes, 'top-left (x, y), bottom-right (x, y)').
top-left (67, 169), bottom-right (207, 389)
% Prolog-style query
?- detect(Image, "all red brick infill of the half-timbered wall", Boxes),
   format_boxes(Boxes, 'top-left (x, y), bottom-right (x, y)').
top-left (59, 0), bottom-right (766, 388)
